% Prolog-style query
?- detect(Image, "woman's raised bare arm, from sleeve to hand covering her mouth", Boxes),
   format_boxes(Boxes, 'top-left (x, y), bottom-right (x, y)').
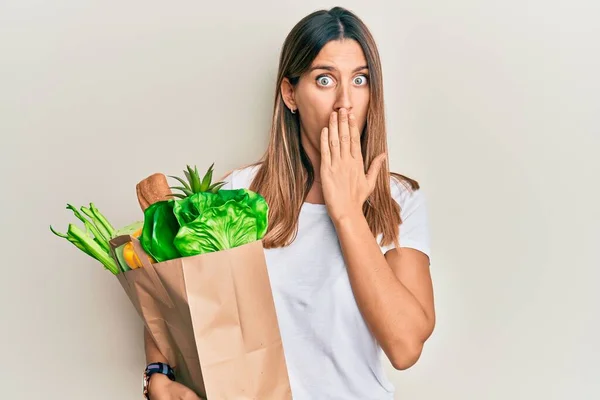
top-left (319, 108), bottom-right (435, 369)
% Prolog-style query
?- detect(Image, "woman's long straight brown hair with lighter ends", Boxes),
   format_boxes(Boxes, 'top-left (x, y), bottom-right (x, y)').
top-left (241, 7), bottom-right (419, 248)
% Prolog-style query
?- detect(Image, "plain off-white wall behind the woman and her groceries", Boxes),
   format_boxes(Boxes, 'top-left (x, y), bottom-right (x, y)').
top-left (0, 0), bottom-right (600, 400)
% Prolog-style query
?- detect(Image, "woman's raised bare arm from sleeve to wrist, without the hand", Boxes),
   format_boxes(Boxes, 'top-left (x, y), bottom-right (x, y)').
top-left (335, 215), bottom-right (435, 369)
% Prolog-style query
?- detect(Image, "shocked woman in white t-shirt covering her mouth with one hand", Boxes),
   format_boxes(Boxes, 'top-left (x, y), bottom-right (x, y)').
top-left (146, 7), bottom-right (435, 400)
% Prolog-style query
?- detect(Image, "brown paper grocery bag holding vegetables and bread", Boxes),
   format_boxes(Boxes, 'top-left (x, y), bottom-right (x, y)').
top-left (111, 235), bottom-right (292, 400)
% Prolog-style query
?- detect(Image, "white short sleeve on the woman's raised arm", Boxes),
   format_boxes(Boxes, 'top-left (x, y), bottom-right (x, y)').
top-left (379, 180), bottom-right (431, 259)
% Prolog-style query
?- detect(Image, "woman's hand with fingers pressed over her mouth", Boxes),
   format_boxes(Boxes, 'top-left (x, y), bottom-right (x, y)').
top-left (321, 108), bottom-right (386, 222)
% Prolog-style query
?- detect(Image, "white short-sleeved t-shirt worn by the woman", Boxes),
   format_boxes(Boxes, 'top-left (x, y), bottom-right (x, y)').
top-left (223, 166), bottom-right (430, 400)
